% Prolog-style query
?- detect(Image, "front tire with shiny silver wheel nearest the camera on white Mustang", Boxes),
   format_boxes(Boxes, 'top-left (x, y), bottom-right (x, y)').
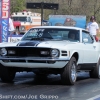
top-left (61, 57), bottom-right (77, 85)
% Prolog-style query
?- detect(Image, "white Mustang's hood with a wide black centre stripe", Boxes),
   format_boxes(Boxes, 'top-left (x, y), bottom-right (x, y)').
top-left (0, 41), bottom-right (75, 48)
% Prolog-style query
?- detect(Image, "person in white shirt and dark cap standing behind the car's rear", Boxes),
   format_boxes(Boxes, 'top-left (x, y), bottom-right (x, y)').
top-left (87, 16), bottom-right (99, 37)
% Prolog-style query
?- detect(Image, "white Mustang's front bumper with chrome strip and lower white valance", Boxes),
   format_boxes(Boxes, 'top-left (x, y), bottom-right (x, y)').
top-left (0, 57), bottom-right (69, 68)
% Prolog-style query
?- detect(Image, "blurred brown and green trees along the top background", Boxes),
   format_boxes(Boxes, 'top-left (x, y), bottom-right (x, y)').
top-left (10, 0), bottom-right (100, 23)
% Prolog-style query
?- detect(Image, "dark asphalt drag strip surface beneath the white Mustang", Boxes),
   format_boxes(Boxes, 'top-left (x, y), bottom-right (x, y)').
top-left (0, 72), bottom-right (100, 100)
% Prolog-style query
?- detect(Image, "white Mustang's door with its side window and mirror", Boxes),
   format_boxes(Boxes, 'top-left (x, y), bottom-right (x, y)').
top-left (82, 31), bottom-right (97, 63)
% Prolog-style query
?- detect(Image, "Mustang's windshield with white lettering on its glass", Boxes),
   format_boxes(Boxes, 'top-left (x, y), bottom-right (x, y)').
top-left (22, 28), bottom-right (80, 42)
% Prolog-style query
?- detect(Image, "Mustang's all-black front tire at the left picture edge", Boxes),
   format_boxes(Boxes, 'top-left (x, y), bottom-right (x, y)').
top-left (0, 64), bottom-right (16, 82)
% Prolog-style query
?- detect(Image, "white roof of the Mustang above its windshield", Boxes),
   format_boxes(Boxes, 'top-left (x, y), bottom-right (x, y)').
top-left (33, 26), bottom-right (86, 31)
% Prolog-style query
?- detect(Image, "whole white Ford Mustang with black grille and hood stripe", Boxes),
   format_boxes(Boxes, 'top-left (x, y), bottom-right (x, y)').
top-left (0, 26), bottom-right (100, 85)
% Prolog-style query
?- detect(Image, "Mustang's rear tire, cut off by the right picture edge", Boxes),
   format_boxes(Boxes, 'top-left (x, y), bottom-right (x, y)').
top-left (89, 59), bottom-right (100, 79)
